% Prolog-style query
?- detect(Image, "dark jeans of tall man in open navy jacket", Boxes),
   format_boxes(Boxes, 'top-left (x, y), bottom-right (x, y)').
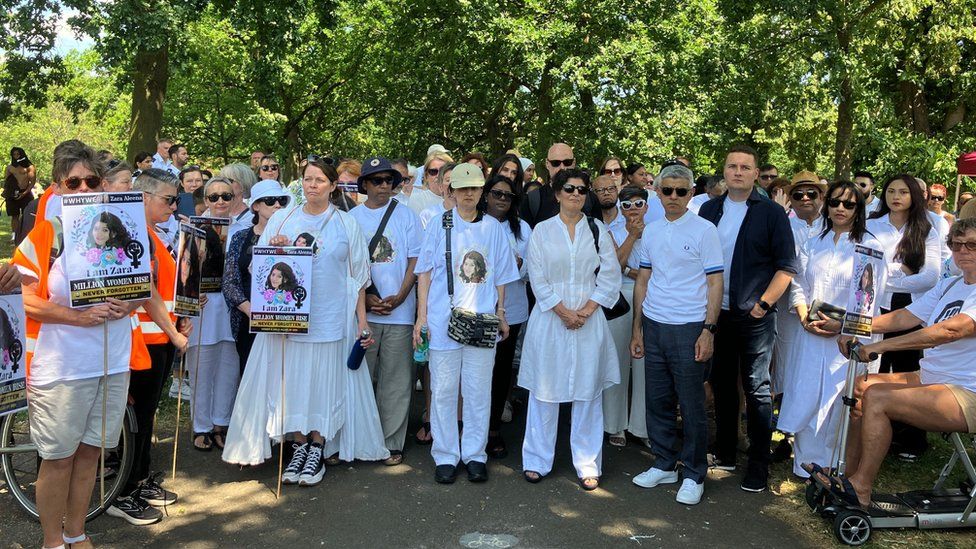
top-left (711, 311), bottom-right (776, 466)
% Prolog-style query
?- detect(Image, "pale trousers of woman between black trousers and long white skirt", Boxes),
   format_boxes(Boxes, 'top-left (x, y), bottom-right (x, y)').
top-left (186, 341), bottom-right (241, 433)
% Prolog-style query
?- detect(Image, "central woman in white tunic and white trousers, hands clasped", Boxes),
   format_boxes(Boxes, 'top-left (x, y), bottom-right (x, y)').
top-left (519, 169), bottom-right (620, 490)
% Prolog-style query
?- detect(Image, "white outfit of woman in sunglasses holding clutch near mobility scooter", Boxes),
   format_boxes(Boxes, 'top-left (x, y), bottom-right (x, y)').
top-left (778, 232), bottom-right (885, 477)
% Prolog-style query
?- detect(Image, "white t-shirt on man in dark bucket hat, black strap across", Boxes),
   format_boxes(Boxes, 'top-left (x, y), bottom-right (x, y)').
top-left (349, 200), bottom-right (423, 326)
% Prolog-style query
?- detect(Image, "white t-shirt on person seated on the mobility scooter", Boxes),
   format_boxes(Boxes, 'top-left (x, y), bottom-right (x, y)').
top-left (907, 277), bottom-right (976, 392)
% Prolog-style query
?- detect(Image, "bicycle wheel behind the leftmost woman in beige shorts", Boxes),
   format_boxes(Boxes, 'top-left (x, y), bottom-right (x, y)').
top-left (0, 406), bottom-right (135, 520)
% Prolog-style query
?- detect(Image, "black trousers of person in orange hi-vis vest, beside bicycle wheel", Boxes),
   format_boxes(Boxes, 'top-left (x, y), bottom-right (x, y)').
top-left (125, 343), bottom-right (176, 493)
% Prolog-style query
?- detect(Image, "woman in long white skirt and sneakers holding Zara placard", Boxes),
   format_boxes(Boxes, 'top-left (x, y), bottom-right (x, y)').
top-left (223, 160), bottom-right (389, 486)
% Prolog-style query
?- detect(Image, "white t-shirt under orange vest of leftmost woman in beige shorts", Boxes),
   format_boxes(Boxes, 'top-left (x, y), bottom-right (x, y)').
top-left (24, 249), bottom-right (133, 386)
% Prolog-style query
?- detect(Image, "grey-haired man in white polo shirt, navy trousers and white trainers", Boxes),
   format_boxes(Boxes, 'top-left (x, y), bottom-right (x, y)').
top-left (630, 165), bottom-right (724, 505)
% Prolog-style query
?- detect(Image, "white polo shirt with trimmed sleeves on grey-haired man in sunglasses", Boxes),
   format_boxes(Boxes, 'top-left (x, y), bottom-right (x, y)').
top-left (638, 210), bottom-right (725, 324)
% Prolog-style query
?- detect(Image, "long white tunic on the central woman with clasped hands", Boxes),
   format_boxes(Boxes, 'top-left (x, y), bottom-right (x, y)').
top-left (518, 216), bottom-right (620, 402)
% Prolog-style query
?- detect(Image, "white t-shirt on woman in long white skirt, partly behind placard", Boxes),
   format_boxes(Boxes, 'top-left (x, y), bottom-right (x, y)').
top-left (258, 206), bottom-right (368, 343)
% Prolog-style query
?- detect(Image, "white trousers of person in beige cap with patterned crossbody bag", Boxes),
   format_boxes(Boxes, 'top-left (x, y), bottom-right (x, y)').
top-left (430, 345), bottom-right (495, 465)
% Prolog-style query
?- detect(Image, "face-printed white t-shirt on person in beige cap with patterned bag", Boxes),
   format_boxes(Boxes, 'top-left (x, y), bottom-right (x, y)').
top-left (415, 209), bottom-right (519, 351)
